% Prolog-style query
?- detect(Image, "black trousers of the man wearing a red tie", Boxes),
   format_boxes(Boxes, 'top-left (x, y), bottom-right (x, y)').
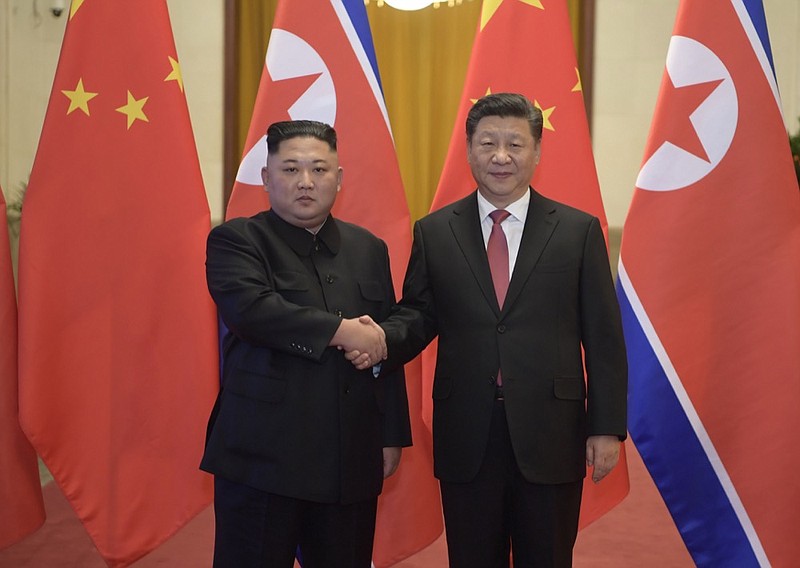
top-left (440, 400), bottom-right (583, 568)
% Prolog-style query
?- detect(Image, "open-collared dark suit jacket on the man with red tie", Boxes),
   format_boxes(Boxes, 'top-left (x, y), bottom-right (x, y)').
top-left (383, 190), bottom-right (627, 484)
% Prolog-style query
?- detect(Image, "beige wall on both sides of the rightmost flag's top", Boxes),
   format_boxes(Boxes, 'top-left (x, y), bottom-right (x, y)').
top-left (592, 0), bottom-right (800, 227)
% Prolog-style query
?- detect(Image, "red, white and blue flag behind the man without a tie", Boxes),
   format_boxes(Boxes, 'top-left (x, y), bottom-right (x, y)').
top-left (227, 0), bottom-right (442, 568)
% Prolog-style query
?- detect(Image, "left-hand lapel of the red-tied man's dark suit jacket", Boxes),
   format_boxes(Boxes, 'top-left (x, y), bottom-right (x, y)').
top-left (450, 192), bottom-right (500, 315)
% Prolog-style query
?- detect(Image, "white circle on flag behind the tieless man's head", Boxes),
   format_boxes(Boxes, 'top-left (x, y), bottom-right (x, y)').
top-left (236, 28), bottom-right (336, 186)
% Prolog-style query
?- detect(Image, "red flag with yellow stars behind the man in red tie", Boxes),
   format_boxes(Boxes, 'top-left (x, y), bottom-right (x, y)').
top-left (423, 0), bottom-right (629, 527)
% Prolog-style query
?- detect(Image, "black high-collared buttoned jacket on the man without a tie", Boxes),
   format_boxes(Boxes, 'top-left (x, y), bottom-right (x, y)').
top-left (201, 211), bottom-right (411, 503)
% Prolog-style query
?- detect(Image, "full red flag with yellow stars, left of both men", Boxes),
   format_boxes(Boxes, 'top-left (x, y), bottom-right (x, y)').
top-left (19, 0), bottom-right (218, 566)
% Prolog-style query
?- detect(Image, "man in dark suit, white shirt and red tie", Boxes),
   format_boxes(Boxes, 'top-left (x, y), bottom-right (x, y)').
top-left (348, 93), bottom-right (627, 568)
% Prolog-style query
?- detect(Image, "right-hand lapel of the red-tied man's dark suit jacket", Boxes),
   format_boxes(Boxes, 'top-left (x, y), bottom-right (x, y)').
top-left (506, 189), bottom-right (558, 312)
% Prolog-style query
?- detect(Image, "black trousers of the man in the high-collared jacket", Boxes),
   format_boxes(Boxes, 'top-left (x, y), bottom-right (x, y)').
top-left (214, 477), bottom-right (378, 568)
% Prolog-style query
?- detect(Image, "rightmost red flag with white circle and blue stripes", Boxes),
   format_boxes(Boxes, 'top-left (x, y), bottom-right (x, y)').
top-left (617, 0), bottom-right (800, 567)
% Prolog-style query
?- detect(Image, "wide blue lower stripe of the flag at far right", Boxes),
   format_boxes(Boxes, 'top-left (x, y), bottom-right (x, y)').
top-left (617, 281), bottom-right (759, 568)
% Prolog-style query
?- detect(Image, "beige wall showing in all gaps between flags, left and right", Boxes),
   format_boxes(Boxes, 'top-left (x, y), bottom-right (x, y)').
top-left (0, 0), bottom-right (800, 227)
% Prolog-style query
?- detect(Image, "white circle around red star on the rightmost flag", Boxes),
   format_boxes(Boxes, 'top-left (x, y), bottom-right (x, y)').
top-left (636, 36), bottom-right (739, 191)
